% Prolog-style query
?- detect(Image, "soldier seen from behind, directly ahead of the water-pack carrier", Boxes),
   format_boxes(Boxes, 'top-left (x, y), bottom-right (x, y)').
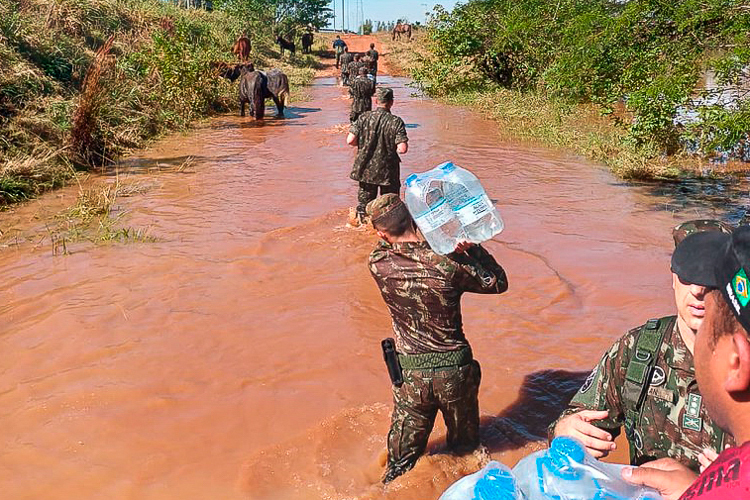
top-left (346, 88), bottom-right (409, 223)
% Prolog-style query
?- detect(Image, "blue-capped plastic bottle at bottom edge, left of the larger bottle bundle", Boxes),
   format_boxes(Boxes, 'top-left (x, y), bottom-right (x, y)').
top-left (439, 460), bottom-right (523, 500)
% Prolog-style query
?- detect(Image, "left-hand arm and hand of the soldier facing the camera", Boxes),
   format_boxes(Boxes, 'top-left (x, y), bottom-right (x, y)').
top-left (548, 335), bottom-right (629, 458)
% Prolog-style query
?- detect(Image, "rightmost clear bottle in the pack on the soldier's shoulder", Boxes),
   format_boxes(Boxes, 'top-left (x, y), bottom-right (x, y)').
top-left (437, 161), bottom-right (505, 243)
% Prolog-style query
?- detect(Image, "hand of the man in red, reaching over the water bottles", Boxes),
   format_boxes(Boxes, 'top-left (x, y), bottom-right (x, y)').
top-left (622, 458), bottom-right (698, 500)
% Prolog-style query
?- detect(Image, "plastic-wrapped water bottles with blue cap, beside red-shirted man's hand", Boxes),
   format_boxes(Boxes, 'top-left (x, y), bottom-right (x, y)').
top-left (513, 437), bottom-right (661, 500)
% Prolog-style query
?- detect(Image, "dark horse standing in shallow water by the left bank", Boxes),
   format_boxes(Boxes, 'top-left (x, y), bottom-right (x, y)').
top-left (240, 67), bottom-right (289, 120)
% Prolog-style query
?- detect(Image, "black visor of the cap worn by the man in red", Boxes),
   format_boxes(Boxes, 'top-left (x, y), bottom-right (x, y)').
top-left (672, 231), bottom-right (729, 288)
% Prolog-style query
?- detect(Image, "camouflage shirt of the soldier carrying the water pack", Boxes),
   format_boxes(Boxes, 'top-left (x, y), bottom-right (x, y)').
top-left (369, 241), bottom-right (508, 355)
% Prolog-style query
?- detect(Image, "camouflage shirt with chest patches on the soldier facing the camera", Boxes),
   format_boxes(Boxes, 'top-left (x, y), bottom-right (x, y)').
top-left (549, 316), bottom-right (731, 472)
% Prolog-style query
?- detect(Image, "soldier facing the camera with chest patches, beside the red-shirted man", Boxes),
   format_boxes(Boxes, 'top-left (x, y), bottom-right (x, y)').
top-left (549, 221), bottom-right (733, 472)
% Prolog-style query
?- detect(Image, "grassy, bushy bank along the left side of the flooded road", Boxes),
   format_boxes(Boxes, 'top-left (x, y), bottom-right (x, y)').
top-left (0, 0), bottom-right (327, 209)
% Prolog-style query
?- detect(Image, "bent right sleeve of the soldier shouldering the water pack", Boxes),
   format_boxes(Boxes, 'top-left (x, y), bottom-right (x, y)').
top-left (450, 245), bottom-right (508, 293)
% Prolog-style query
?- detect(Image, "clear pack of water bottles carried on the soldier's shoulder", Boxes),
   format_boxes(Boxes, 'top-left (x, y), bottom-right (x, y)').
top-left (404, 162), bottom-right (504, 255)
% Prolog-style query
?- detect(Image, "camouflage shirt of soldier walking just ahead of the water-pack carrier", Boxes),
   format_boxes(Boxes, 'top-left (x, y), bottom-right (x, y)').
top-left (349, 108), bottom-right (409, 186)
